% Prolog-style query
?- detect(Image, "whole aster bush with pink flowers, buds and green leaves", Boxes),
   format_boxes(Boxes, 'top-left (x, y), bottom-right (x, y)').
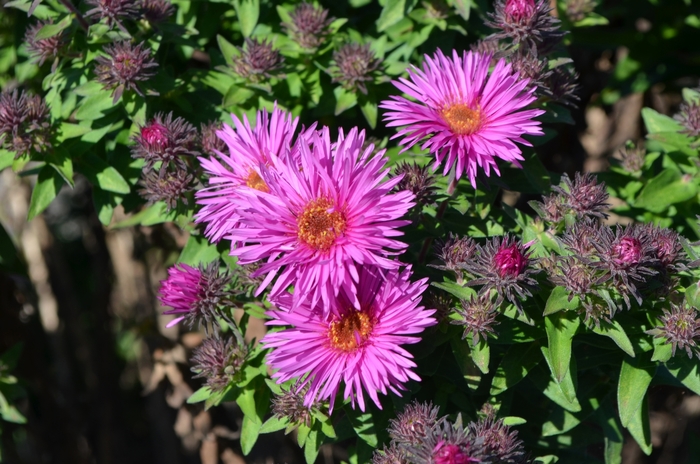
top-left (0, 0), bottom-right (700, 464)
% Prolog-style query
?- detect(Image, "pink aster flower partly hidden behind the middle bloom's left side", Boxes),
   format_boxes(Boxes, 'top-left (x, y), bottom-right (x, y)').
top-left (195, 107), bottom-right (306, 242)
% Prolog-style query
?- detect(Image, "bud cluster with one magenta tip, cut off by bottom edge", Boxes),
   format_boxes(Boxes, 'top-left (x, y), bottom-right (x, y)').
top-left (372, 401), bottom-right (531, 464)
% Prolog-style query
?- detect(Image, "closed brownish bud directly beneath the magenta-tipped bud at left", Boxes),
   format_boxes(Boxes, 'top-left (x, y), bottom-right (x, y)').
top-left (139, 168), bottom-right (194, 209)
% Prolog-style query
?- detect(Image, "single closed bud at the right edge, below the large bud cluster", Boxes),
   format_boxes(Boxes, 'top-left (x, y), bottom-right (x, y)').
top-left (647, 304), bottom-right (700, 359)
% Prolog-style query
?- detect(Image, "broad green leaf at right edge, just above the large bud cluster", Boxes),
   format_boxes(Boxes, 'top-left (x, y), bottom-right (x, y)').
top-left (634, 168), bottom-right (698, 213)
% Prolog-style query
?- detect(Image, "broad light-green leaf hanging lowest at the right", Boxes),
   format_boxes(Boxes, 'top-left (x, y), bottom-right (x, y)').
top-left (617, 357), bottom-right (656, 432)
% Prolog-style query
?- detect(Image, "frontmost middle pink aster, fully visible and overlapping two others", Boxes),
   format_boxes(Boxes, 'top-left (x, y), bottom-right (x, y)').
top-left (228, 128), bottom-right (414, 313)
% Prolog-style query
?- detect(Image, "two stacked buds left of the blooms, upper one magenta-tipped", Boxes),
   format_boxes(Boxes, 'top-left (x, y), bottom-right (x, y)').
top-left (131, 113), bottom-right (199, 209)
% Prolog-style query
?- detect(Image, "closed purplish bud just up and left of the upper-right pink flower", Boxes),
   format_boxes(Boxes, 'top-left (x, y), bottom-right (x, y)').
top-left (331, 43), bottom-right (379, 94)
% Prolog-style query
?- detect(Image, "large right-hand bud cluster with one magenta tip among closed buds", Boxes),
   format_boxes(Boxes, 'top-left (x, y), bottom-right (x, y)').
top-left (533, 174), bottom-right (687, 326)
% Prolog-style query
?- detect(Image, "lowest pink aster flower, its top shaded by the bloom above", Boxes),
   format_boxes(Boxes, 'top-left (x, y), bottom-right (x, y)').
top-left (262, 267), bottom-right (435, 411)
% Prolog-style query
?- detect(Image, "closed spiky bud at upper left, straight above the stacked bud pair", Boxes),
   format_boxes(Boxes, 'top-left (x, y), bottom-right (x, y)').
top-left (95, 41), bottom-right (158, 103)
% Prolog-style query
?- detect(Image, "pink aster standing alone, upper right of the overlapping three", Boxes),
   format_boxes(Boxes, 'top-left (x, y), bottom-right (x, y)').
top-left (380, 50), bottom-right (544, 186)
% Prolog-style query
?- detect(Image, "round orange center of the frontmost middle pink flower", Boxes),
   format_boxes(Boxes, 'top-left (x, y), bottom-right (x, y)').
top-left (297, 198), bottom-right (345, 251)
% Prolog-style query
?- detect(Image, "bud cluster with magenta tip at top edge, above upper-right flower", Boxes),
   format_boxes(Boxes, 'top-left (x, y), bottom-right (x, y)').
top-left (472, 0), bottom-right (579, 105)
